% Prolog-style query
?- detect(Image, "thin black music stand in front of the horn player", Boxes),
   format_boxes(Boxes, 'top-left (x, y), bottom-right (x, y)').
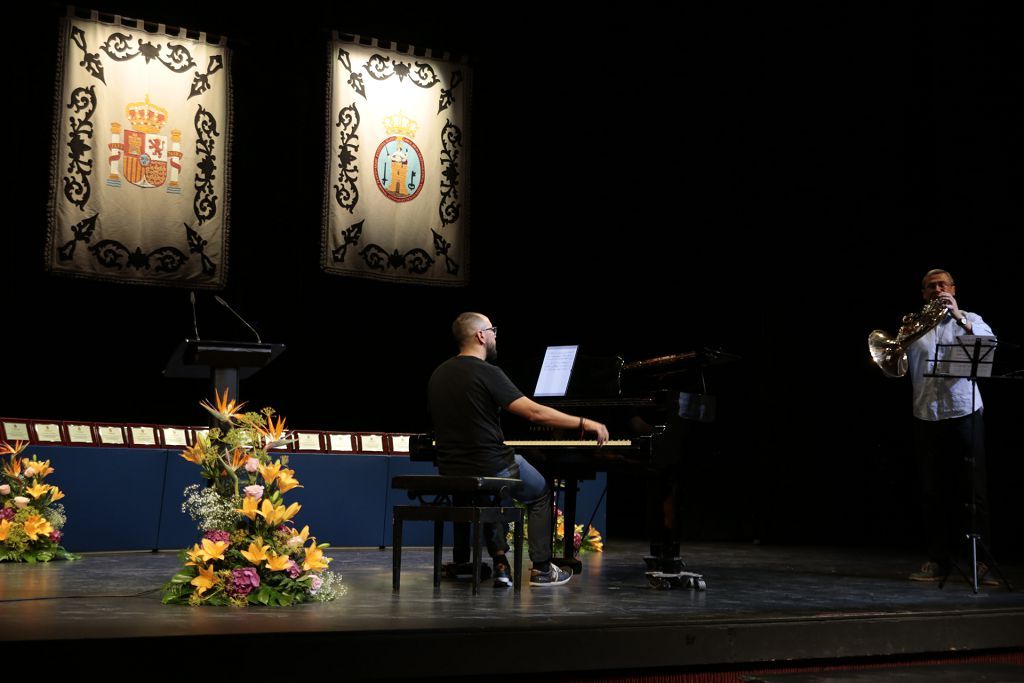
top-left (924, 335), bottom-right (1014, 594)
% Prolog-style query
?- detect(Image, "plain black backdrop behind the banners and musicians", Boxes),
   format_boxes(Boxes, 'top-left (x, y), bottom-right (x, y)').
top-left (0, 2), bottom-right (1024, 553)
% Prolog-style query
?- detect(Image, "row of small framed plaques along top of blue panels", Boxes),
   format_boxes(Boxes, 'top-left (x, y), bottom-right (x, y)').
top-left (0, 420), bottom-right (410, 454)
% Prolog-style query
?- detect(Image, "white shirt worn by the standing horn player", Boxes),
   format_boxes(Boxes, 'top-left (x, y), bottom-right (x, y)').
top-left (906, 310), bottom-right (992, 422)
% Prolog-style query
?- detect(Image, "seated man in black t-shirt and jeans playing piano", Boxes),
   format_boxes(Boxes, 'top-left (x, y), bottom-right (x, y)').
top-left (427, 312), bottom-right (608, 587)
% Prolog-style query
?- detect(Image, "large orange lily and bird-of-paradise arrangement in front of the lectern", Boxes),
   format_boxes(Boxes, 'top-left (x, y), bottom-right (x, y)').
top-left (163, 389), bottom-right (343, 606)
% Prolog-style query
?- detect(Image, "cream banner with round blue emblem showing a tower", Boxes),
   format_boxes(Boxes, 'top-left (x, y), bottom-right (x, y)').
top-left (322, 36), bottom-right (471, 285)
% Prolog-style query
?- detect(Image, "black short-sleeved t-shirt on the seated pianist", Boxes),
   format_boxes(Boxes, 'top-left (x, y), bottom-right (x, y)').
top-left (427, 355), bottom-right (523, 475)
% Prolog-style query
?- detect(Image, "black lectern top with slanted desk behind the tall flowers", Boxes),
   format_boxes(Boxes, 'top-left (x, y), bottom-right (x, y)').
top-left (164, 339), bottom-right (285, 409)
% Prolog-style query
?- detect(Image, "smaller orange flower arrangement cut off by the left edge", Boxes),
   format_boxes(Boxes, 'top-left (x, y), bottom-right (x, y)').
top-left (0, 441), bottom-right (78, 562)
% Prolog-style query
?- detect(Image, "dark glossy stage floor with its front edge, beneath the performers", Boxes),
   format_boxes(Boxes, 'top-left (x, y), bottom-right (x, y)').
top-left (0, 542), bottom-right (1024, 680)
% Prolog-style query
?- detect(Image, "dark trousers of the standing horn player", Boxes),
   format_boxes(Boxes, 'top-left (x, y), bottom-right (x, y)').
top-left (913, 411), bottom-right (989, 568)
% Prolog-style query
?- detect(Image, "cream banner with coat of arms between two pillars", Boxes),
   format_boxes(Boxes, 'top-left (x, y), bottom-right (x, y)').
top-left (46, 13), bottom-right (231, 288)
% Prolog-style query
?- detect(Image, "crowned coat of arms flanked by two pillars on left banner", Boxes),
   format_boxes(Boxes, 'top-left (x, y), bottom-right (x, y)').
top-left (106, 94), bottom-right (182, 193)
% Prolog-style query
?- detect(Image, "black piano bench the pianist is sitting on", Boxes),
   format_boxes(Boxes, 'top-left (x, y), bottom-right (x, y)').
top-left (391, 474), bottom-right (523, 595)
